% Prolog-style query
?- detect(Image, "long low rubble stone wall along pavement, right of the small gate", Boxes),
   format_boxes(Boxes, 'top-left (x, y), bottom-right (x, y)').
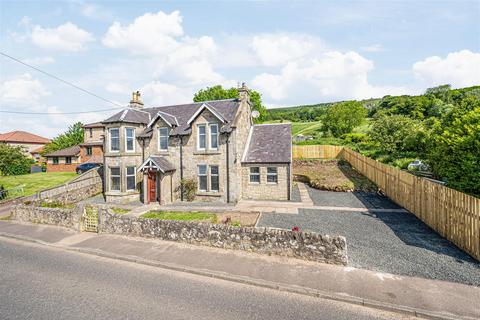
top-left (99, 209), bottom-right (347, 265)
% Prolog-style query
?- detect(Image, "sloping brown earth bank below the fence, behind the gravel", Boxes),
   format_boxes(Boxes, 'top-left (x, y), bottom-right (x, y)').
top-left (293, 160), bottom-right (378, 192)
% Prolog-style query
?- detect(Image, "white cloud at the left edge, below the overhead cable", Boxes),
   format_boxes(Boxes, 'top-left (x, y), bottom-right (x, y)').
top-left (0, 73), bottom-right (50, 106)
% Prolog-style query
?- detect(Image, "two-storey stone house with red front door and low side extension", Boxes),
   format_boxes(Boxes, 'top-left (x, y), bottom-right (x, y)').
top-left (102, 85), bottom-right (292, 204)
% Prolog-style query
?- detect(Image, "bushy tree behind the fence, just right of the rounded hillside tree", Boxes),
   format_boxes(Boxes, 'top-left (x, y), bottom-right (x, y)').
top-left (369, 114), bottom-right (427, 155)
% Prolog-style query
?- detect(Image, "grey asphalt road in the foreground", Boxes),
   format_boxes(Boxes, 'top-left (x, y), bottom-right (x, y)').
top-left (0, 237), bottom-right (408, 320)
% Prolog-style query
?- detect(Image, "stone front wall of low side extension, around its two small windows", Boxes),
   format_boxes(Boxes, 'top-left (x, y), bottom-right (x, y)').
top-left (242, 164), bottom-right (292, 200)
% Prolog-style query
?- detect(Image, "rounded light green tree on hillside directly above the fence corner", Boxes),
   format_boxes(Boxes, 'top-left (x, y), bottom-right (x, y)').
top-left (322, 101), bottom-right (368, 137)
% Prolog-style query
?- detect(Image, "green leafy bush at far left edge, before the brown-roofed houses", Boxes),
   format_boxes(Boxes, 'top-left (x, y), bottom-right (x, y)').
top-left (0, 143), bottom-right (34, 176)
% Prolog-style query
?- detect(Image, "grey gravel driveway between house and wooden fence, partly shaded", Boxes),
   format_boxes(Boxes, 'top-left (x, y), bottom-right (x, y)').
top-left (258, 189), bottom-right (480, 286)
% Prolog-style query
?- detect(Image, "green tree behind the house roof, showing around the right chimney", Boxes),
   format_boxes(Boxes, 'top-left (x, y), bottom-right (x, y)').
top-left (193, 85), bottom-right (267, 121)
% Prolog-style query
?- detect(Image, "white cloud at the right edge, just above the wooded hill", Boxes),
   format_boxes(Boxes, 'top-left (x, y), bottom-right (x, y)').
top-left (412, 50), bottom-right (480, 88)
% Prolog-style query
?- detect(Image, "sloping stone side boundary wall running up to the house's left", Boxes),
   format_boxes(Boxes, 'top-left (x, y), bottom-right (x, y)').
top-left (36, 167), bottom-right (103, 203)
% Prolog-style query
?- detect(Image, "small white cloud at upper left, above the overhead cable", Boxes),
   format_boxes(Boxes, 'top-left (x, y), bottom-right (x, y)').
top-left (30, 22), bottom-right (94, 52)
